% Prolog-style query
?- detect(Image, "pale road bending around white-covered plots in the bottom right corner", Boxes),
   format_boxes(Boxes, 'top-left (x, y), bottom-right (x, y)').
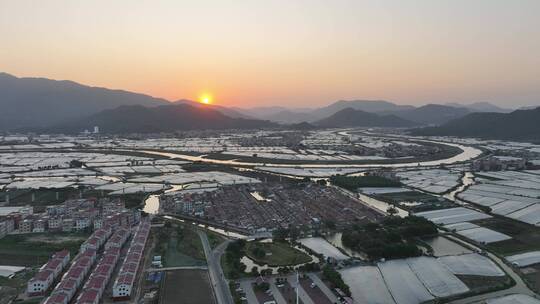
top-left (448, 236), bottom-right (538, 304)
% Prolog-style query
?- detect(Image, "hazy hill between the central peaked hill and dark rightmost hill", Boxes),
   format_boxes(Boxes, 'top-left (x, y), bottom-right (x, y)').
top-left (384, 104), bottom-right (470, 125)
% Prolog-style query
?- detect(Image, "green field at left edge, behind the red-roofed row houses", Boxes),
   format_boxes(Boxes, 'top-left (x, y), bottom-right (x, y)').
top-left (0, 233), bottom-right (89, 267)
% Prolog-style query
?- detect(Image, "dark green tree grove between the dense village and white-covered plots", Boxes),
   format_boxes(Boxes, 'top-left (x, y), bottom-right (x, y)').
top-left (342, 216), bottom-right (437, 260)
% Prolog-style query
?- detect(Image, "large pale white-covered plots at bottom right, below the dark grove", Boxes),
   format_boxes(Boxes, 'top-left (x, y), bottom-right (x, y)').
top-left (339, 254), bottom-right (507, 304)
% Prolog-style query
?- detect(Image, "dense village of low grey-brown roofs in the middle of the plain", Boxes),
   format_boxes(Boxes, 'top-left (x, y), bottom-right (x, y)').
top-left (160, 183), bottom-right (380, 233)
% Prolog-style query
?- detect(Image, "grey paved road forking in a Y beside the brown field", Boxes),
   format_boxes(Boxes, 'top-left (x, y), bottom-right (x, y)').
top-left (197, 230), bottom-right (234, 304)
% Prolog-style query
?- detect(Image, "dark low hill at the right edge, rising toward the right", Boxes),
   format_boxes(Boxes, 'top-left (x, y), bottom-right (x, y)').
top-left (412, 107), bottom-right (540, 141)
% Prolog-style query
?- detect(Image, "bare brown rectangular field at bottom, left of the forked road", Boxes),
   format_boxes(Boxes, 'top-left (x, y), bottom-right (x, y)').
top-left (162, 270), bottom-right (215, 304)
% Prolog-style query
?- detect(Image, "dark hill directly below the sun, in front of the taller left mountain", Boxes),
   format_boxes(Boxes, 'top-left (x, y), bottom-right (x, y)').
top-left (40, 104), bottom-right (278, 133)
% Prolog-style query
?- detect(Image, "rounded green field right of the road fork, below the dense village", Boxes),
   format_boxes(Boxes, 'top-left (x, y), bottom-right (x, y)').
top-left (246, 242), bottom-right (311, 266)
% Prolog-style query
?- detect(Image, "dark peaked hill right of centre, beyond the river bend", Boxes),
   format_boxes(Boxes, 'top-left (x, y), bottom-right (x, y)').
top-left (314, 108), bottom-right (418, 128)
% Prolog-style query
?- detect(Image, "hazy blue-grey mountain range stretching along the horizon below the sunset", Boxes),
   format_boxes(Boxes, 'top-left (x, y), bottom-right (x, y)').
top-left (0, 73), bottom-right (536, 133)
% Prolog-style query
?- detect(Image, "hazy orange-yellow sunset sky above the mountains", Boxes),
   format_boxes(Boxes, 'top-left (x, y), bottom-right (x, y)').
top-left (0, 0), bottom-right (540, 107)
